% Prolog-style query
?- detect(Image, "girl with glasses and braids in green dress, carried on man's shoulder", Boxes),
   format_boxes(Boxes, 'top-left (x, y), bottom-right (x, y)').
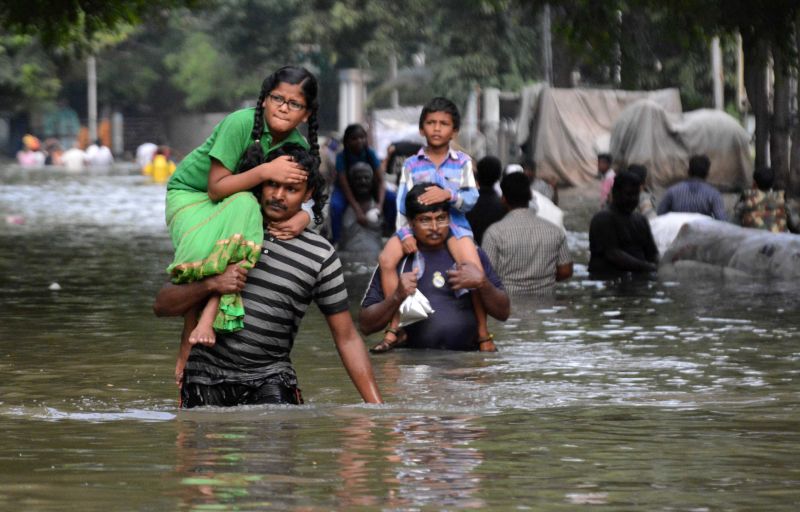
top-left (166, 66), bottom-right (320, 386)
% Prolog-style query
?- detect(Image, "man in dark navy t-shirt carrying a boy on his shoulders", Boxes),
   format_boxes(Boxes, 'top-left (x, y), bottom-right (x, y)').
top-left (359, 183), bottom-right (511, 350)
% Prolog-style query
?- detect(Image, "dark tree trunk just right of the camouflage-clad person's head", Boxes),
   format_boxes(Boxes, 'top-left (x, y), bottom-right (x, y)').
top-left (769, 46), bottom-right (791, 190)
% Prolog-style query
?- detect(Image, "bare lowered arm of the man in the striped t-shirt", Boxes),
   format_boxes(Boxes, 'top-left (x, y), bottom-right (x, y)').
top-left (325, 311), bottom-right (383, 404)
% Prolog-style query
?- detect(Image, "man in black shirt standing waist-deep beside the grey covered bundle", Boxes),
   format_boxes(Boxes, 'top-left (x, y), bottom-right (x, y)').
top-left (589, 171), bottom-right (658, 278)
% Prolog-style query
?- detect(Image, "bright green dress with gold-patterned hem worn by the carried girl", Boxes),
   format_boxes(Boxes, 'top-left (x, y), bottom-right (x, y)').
top-left (166, 108), bottom-right (308, 332)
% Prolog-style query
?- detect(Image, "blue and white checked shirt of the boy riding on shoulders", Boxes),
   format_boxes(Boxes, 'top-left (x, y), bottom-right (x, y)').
top-left (397, 148), bottom-right (478, 240)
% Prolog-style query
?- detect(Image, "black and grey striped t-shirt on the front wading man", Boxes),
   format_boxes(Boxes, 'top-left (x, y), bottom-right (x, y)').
top-left (185, 230), bottom-right (348, 385)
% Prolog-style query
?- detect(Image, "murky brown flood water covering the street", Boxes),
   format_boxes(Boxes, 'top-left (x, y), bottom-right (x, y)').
top-left (0, 167), bottom-right (800, 512)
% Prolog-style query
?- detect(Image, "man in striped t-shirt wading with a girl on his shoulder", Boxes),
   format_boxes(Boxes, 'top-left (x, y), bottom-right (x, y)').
top-left (153, 158), bottom-right (382, 408)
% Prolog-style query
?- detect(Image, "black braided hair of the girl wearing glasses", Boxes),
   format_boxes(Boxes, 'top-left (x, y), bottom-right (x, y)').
top-left (236, 66), bottom-right (320, 172)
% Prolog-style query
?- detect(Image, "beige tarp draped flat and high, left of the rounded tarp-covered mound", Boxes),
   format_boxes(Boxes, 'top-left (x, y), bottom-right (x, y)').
top-left (517, 85), bottom-right (681, 185)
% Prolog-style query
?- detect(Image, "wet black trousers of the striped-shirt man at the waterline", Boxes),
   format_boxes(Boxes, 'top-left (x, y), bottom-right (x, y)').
top-left (181, 379), bottom-right (303, 409)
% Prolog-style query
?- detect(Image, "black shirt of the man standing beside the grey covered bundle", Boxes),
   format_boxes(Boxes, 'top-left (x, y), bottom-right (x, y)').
top-left (589, 207), bottom-right (658, 277)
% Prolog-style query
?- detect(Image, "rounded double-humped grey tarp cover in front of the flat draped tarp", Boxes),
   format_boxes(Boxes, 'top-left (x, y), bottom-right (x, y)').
top-left (610, 100), bottom-right (753, 190)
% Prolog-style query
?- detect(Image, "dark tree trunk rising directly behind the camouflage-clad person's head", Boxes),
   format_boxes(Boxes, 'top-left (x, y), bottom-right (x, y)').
top-left (742, 33), bottom-right (769, 169)
